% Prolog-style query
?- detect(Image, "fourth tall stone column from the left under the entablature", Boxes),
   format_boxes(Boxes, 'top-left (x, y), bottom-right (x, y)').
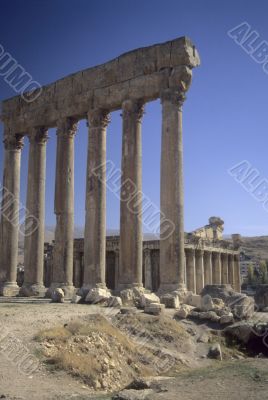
top-left (81, 110), bottom-right (110, 296)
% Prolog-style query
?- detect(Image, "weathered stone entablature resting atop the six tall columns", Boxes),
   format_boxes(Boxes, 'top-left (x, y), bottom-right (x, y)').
top-left (1, 37), bottom-right (200, 134)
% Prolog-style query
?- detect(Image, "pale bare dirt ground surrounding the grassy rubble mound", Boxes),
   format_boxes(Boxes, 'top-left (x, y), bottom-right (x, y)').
top-left (0, 299), bottom-right (268, 400)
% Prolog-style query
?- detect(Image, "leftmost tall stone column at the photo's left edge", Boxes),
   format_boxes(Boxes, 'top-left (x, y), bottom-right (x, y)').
top-left (0, 132), bottom-right (23, 296)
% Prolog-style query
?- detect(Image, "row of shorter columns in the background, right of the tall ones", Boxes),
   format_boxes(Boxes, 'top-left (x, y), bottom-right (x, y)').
top-left (185, 248), bottom-right (241, 294)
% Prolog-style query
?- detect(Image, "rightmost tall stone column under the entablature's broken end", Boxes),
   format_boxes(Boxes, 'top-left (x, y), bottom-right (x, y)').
top-left (160, 89), bottom-right (185, 292)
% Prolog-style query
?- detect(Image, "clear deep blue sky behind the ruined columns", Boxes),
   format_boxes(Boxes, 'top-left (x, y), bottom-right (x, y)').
top-left (0, 0), bottom-right (268, 236)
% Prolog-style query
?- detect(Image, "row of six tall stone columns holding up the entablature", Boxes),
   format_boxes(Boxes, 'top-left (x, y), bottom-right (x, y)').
top-left (0, 89), bottom-right (191, 296)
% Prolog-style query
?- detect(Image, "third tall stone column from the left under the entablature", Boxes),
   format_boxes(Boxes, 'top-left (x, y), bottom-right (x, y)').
top-left (49, 118), bottom-right (77, 298)
